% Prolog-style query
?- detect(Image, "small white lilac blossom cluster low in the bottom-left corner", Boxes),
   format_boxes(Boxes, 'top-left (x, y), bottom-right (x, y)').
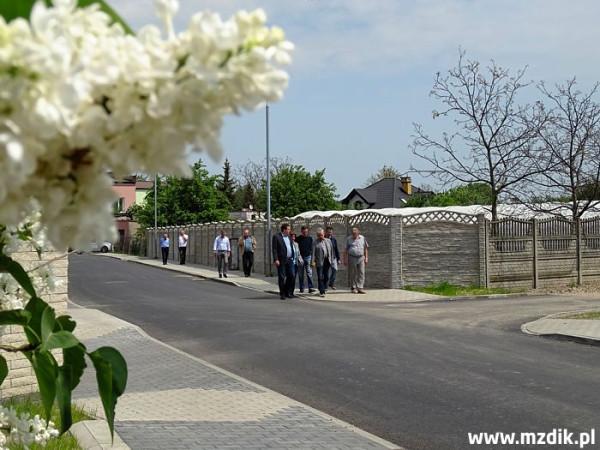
top-left (0, 406), bottom-right (59, 450)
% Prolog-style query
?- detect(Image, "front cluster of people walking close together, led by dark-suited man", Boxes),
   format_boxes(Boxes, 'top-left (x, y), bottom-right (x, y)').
top-left (272, 223), bottom-right (369, 300)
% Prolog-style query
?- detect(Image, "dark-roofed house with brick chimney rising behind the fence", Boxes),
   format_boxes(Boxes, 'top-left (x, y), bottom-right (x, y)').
top-left (342, 177), bottom-right (433, 209)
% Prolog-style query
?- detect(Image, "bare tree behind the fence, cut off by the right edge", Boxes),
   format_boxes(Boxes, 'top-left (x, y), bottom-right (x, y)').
top-left (530, 79), bottom-right (600, 220)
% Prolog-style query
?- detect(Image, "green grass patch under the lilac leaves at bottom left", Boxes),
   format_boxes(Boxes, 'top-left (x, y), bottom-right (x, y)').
top-left (2, 395), bottom-right (93, 450)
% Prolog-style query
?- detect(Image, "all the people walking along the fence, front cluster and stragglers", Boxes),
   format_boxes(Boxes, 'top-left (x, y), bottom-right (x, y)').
top-left (160, 223), bottom-right (369, 300)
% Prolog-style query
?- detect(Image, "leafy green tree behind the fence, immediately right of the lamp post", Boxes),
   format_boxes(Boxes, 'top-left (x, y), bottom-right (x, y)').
top-left (258, 164), bottom-right (339, 217)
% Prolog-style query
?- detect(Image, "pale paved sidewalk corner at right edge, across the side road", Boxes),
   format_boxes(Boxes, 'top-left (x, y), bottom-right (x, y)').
top-left (521, 311), bottom-right (600, 342)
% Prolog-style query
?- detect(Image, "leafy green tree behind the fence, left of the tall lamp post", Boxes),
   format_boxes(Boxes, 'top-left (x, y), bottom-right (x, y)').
top-left (128, 161), bottom-right (231, 227)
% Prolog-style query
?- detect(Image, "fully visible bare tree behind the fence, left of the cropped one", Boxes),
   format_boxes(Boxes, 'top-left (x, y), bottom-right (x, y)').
top-left (412, 51), bottom-right (545, 219)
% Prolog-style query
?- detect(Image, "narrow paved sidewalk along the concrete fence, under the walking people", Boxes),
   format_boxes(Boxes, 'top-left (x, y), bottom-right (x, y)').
top-left (98, 253), bottom-right (447, 303)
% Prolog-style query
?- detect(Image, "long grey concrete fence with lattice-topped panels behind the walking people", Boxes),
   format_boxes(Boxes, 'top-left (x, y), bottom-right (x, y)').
top-left (146, 210), bottom-right (600, 288)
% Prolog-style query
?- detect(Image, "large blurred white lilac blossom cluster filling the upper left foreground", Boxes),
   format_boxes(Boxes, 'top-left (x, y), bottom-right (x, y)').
top-left (0, 0), bottom-right (293, 249)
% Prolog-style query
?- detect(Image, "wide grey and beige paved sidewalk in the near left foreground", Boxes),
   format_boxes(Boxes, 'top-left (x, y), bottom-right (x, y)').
top-left (69, 305), bottom-right (399, 450)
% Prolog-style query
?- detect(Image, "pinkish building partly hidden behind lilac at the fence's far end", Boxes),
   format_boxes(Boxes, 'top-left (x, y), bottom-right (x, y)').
top-left (113, 175), bottom-right (154, 249)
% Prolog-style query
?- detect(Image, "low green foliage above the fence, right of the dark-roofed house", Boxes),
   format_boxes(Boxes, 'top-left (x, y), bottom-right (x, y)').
top-left (406, 183), bottom-right (492, 207)
